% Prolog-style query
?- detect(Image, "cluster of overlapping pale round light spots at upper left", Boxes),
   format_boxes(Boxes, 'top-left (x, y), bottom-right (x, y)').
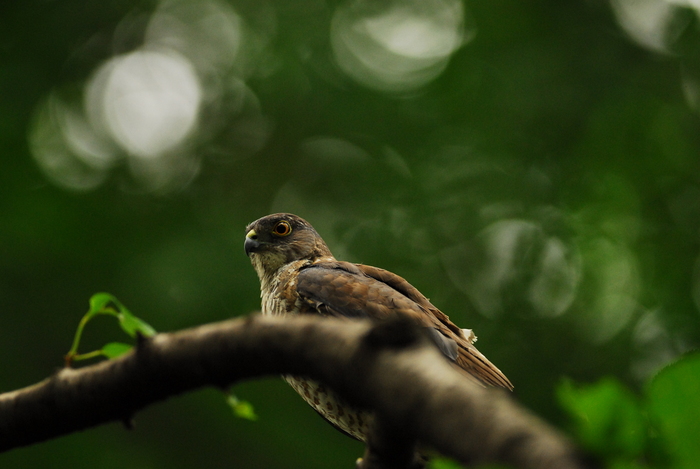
top-left (28, 0), bottom-right (264, 194)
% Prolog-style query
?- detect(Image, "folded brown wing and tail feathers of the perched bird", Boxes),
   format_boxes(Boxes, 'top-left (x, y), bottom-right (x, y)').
top-left (296, 261), bottom-right (513, 389)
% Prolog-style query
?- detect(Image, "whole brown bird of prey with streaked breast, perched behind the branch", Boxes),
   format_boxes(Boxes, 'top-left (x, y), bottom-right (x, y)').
top-left (245, 213), bottom-right (513, 441)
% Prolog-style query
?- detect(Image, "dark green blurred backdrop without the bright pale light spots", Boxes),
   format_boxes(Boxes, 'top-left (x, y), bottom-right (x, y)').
top-left (0, 0), bottom-right (700, 468)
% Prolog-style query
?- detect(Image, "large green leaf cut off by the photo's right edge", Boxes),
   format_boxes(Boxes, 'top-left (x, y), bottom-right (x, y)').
top-left (647, 353), bottom-right (700, 469)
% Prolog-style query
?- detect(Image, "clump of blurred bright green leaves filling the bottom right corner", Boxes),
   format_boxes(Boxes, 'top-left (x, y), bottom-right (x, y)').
top-left (558, 353), bottom-right (700, 469)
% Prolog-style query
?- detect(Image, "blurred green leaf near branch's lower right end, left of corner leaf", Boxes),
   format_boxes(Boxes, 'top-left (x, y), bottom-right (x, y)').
top-left (557, 378), bottom-right (647, 459)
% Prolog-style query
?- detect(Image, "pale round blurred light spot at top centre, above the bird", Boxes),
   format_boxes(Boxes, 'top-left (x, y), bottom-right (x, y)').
top-left (331, 0), bottom-right (474, 92)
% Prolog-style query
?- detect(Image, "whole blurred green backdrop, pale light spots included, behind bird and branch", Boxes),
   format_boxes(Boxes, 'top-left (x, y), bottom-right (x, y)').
top-left (0, 0), bottom-right (700, 469)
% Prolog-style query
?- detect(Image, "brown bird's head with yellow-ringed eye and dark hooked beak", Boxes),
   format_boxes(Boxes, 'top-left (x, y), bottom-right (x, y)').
top-left (244, 213), bottom-right (333, 279)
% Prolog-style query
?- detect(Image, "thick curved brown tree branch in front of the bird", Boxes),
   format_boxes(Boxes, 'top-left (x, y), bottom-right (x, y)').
top-left (0, 315), bottom-right (589, 469)
